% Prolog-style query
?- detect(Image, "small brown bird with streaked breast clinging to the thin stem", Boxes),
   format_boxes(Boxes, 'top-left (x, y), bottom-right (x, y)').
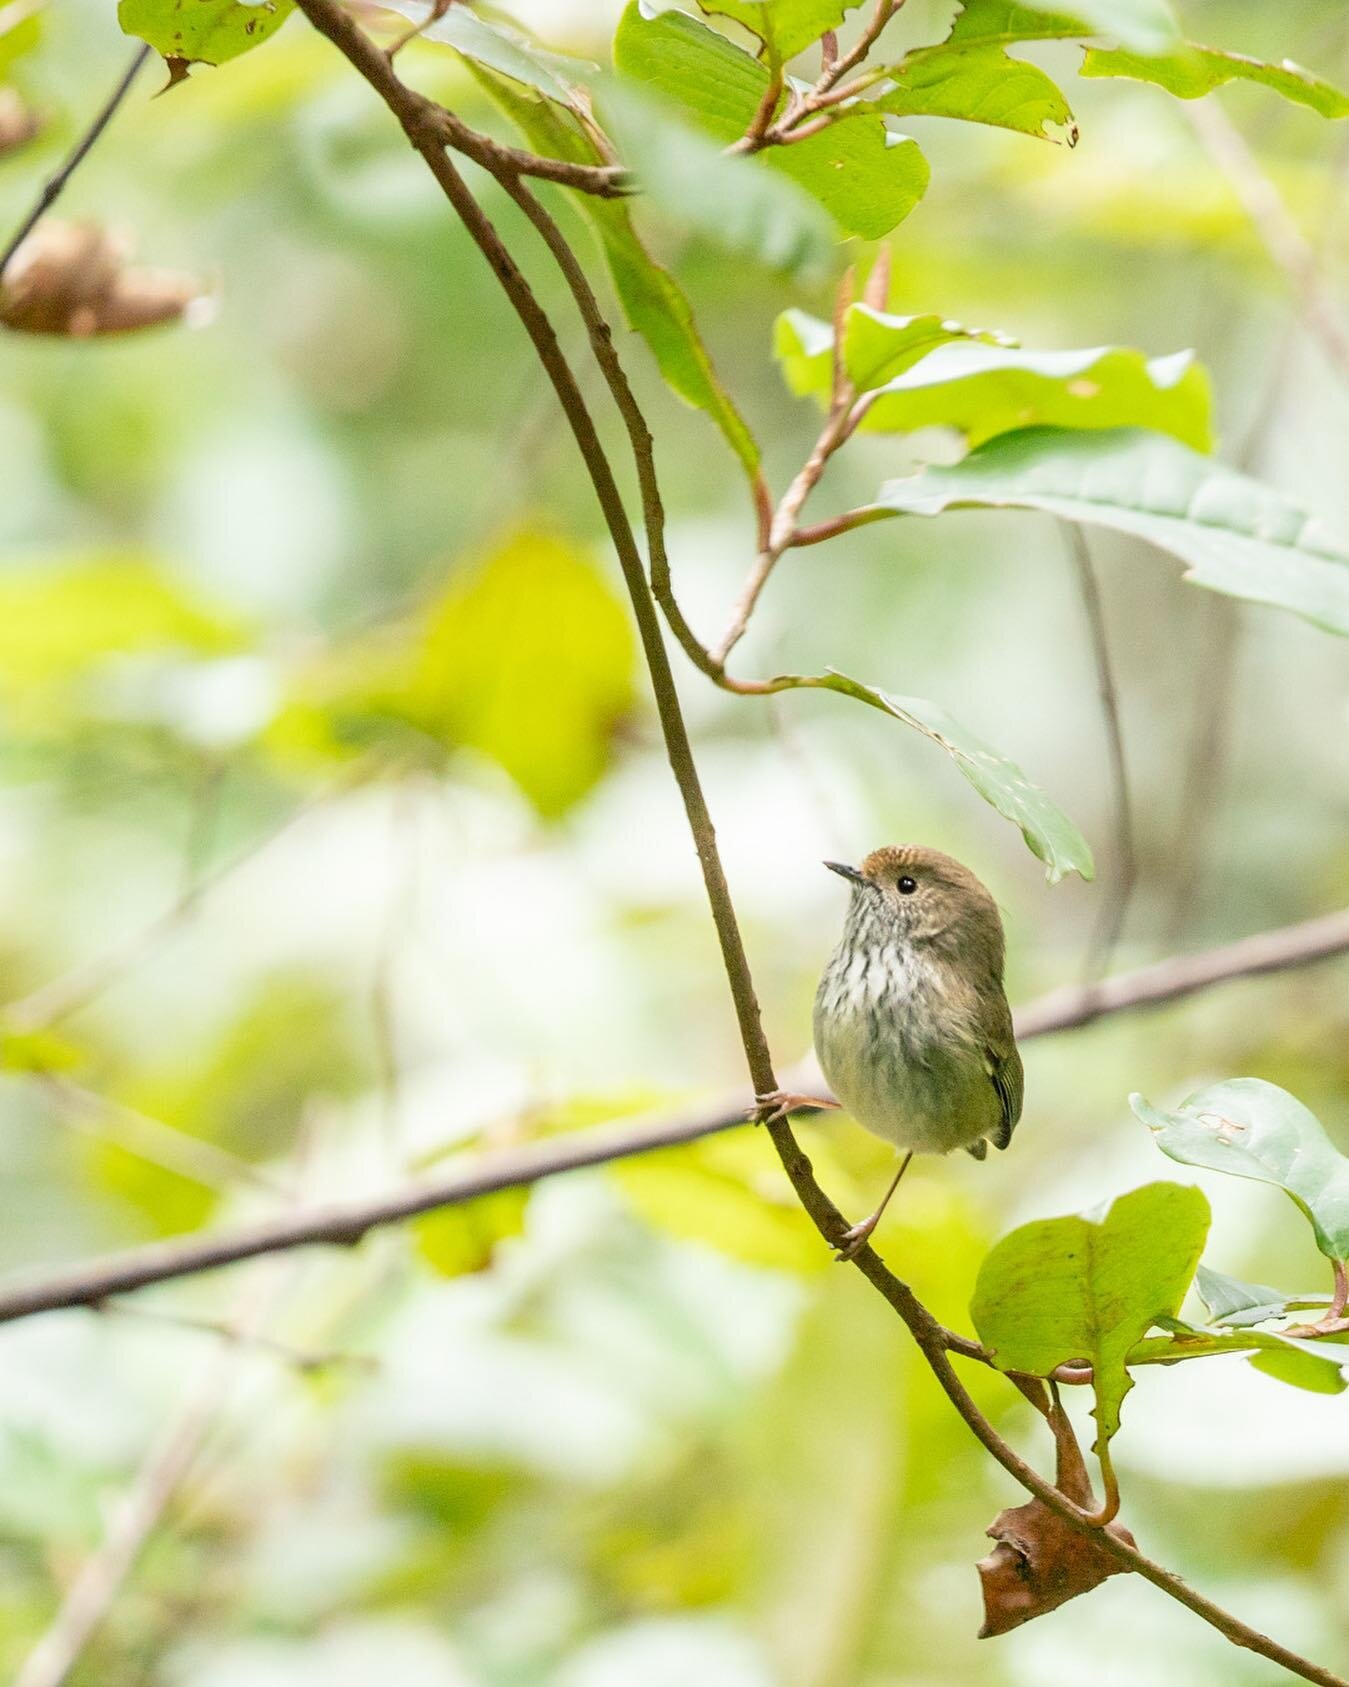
top-left (759, 844), bottom-right (1022, 1259)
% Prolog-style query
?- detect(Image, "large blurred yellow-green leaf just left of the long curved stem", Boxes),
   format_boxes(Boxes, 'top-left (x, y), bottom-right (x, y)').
top-left (405, 531), bottom-right (634, 818)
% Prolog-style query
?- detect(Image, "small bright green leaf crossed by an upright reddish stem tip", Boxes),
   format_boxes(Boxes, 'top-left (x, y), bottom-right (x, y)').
top-left (772, 304), bottom-right (1010, 407)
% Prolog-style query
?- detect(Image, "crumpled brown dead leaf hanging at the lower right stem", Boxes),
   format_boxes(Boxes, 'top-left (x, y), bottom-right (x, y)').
top-left (976, 1500), bottom-right (1135, 1640)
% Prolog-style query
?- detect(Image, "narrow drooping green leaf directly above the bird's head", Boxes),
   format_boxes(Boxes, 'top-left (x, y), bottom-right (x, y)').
top-left (794, 670), bottom-right (1096, 884)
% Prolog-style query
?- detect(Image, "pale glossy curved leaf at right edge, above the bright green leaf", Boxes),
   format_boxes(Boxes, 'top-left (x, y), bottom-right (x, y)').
top-left (1130, 1078), bottom-right (1349, 1260)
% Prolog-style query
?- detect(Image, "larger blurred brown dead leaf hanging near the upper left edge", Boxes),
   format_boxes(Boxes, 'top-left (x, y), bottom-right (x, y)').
top-left (0, 219), bottom-right (209, 339)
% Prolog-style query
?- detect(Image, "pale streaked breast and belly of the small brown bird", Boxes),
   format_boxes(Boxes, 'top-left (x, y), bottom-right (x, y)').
top-left (814, 970), bottom-right (1000, 1154)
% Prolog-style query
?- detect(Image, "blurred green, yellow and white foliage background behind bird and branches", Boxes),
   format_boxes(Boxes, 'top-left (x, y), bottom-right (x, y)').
top-left (0, 0), bottom-right (1349, 1687)
